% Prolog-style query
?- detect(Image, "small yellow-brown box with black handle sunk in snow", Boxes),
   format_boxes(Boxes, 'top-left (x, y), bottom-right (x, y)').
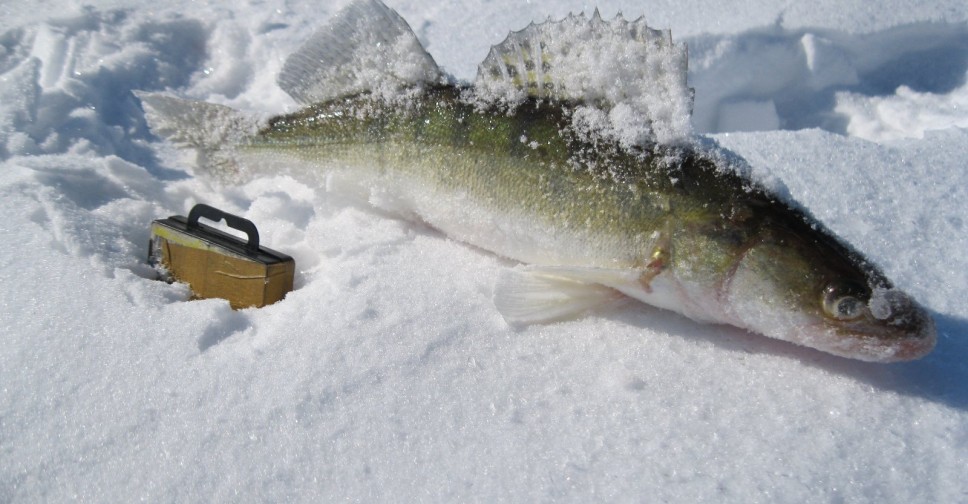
top-left (148, 204), bottom-right (296, 309)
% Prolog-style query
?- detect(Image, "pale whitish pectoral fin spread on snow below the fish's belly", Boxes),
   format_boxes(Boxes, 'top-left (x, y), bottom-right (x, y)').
top-left (494, 267), bottom-right (623, 325)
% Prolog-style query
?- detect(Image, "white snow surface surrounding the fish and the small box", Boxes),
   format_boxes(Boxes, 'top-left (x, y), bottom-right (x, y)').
top-left (0, 0), bottom-right (968, 502)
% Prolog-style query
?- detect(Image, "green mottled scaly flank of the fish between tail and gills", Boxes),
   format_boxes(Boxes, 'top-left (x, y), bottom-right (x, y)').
top-left (245, 88), bottom-right (684, 267)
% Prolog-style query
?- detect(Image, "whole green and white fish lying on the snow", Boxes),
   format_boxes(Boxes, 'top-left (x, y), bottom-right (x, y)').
top-left (138, 0), bottom-right (937, 362)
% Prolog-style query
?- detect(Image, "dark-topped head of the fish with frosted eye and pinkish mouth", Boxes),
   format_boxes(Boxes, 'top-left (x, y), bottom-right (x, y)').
top-left (723, 220), bottom-right (936, 362)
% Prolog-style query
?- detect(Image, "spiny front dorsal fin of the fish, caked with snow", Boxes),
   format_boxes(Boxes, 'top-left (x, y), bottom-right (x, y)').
top-left (474, 9), bottom-right (692, 145)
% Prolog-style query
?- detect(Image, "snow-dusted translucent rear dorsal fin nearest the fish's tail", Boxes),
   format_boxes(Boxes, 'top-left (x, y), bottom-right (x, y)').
top-left (278, 0), bottom-right (441, 104)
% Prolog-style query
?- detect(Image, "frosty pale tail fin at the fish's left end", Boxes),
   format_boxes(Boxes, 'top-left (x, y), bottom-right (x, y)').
top-left (135, 92), bottom-right (258, 180)
